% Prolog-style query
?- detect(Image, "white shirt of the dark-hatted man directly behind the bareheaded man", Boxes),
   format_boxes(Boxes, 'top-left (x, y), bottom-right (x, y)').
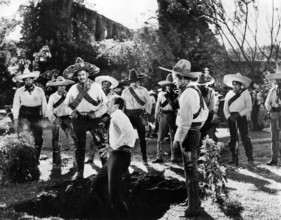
top-left (121, 86), bottom-right (152, 114)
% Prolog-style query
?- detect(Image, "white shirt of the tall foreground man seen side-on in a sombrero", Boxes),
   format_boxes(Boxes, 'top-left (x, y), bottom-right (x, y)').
top-left (174, 84), bottom-right (209, 143)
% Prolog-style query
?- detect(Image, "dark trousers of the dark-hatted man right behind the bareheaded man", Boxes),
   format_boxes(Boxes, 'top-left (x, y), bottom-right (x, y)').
top-left (128, 116), bottom-right (147, 160)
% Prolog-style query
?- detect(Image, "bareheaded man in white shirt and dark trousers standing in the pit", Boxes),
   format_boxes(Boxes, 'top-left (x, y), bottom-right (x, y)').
top-left (93, 96), bottom-right (136, 219)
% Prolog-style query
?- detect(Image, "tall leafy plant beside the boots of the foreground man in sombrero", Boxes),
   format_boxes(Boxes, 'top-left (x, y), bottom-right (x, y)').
top-left (198, 137), bottom-right (227, 203)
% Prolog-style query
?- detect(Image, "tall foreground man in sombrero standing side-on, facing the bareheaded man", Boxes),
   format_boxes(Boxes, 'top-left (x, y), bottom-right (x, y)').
top-left (162, 59), bottom-right (209, 217)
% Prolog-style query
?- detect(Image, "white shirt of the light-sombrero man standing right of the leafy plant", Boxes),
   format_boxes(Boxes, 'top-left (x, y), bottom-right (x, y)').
top-left (223, 90), bottom-right (252, 119)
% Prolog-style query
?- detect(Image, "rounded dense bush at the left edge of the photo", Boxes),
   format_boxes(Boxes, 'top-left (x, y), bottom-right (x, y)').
top-left (0, 135), bottom-right (40, 184)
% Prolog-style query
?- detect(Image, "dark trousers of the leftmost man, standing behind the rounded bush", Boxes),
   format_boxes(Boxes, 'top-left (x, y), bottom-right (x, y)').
top-left (19, 111), bottom-right (43, 161)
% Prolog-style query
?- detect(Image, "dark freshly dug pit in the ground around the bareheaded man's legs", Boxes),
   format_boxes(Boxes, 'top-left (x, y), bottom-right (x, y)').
top-left (14, 172), bottom-right (186, 219)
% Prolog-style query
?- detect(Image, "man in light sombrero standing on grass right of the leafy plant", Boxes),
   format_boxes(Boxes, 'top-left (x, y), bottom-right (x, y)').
top-left (223, 73), bottom-right (254, 165)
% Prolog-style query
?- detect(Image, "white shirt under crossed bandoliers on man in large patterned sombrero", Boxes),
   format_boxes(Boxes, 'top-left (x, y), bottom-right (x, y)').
top-left (65, 82), bottom-right (108, 117)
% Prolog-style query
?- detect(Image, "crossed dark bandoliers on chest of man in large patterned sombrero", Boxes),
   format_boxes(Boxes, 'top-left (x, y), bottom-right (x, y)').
top-left (69, 79), bottom-right (100, 110)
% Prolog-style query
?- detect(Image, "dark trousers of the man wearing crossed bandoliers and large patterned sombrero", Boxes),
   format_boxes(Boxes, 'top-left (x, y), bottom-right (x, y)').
top-left (72, 116), bottom-right (103, 175)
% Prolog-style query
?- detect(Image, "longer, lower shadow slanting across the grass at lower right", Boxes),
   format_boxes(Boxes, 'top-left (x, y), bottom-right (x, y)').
top-left (226, 170), bottom-right (278, 194)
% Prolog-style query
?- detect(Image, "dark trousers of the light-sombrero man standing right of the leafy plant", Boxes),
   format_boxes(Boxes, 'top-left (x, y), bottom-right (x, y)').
top-left (228, 116), bottom-right (253, 160)
